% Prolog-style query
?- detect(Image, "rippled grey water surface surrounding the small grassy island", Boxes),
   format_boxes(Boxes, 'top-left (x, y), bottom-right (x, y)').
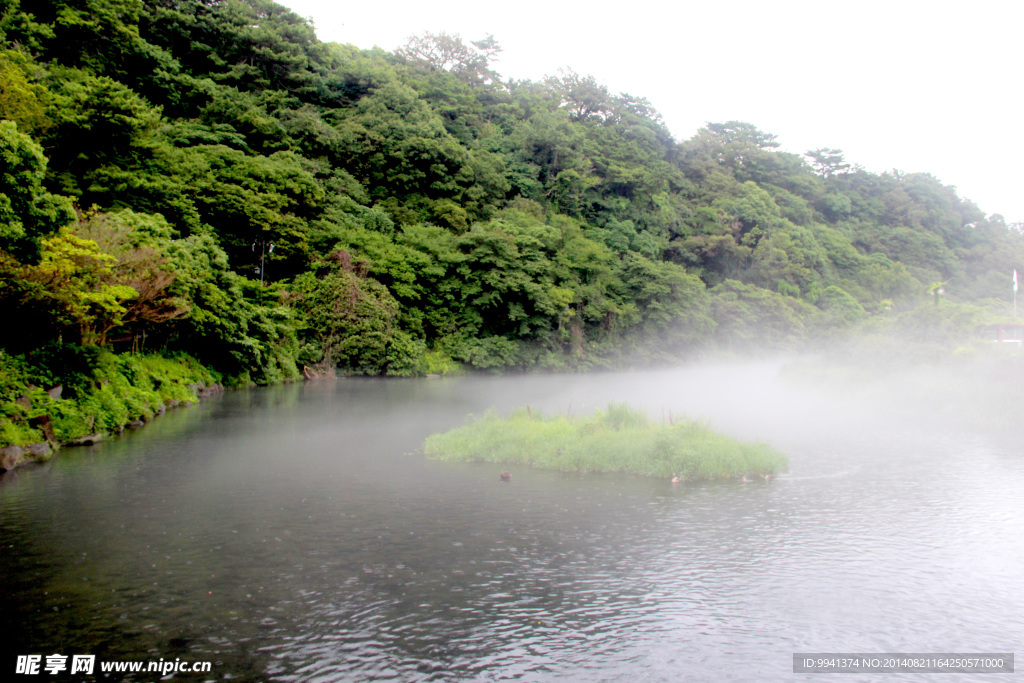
top-left (0, 366), bottom-right (1024, 681)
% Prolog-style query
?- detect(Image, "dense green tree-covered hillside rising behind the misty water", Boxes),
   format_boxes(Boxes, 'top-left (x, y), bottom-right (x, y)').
top-left (0, 0), bottom-right (1024, 417)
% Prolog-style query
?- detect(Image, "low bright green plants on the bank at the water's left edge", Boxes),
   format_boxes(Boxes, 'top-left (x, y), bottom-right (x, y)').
top-left (0, 345), bottom-right (223, 470)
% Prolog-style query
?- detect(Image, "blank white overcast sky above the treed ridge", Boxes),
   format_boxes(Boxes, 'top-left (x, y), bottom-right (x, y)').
top-left (278, 0), bottom-right (1024, 221)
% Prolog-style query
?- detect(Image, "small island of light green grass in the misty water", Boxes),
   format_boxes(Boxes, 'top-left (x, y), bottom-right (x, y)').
top-left (424, 403), bottom-right (786, 480)
